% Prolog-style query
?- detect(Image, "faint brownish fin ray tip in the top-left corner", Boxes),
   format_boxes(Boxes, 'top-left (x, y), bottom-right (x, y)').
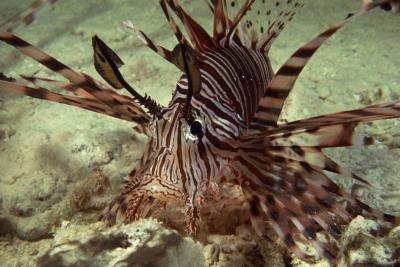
top-left (0, 0), bottom-right (58, 32)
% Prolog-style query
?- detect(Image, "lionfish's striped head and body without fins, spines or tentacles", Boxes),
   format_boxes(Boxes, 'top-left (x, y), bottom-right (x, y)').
top-left (111, 32), bottom-right (272, 230)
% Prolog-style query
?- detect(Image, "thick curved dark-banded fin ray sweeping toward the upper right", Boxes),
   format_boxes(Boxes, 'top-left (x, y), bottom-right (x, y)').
top-left (253, 11), bottom-right (365, 131)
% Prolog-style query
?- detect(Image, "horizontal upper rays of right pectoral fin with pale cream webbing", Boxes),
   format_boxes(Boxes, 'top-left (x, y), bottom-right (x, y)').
top-left (263, 102), bottom-right (400, 195)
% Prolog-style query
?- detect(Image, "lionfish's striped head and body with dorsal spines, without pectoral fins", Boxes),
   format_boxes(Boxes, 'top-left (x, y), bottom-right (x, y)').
top-left (97, 0), bottom-right (301, 222)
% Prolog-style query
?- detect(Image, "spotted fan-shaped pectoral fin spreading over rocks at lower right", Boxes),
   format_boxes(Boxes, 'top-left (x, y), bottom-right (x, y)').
top-left (234, 123), bottom-right (400, 262)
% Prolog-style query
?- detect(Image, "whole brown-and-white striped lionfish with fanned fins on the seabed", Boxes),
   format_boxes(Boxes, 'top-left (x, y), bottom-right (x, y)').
top-left (0, 0), bottom-right (400, 262)
